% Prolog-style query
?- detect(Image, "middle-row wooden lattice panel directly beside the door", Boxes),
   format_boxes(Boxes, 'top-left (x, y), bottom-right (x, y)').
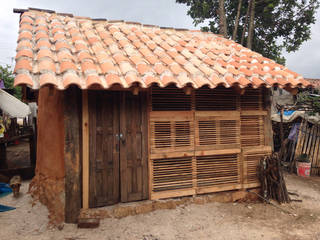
top-left (150, 111), bottom-right (194, 157)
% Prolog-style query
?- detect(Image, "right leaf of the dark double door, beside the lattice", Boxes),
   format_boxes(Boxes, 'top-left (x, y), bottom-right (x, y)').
top-left (120, 92), bottom-right (148, 202)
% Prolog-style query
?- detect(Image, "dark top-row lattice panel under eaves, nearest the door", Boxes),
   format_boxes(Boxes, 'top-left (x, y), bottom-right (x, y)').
top-left (151, 87), bottom-right (191, 111)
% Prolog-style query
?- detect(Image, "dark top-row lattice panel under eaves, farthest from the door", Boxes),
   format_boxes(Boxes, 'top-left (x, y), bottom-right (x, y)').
top-left (240, 88), bottom-right (263, 110)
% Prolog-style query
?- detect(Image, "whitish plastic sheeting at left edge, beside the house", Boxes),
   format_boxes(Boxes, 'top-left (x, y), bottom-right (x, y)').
top-left (0, 89), bottom-right (31, 118)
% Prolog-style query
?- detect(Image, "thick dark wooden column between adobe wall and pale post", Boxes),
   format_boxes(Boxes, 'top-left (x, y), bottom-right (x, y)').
top-left (64, 86), bottom-right (81, 223)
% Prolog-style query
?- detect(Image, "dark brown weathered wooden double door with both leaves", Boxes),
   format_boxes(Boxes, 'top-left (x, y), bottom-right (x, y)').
top-left (88, 91), bottom-right (148, 207)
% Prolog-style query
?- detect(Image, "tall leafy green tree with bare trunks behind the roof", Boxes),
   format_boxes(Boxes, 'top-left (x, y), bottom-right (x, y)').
top-left (176, 0), bottom-right (319, 64)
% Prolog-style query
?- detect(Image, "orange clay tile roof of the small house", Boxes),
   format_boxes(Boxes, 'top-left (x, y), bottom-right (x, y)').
top-left (14, 9), bottom-right (312, 89)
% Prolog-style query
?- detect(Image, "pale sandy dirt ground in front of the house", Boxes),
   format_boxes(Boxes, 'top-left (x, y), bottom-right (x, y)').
top-left (0, 175), bottom-right (320, 240)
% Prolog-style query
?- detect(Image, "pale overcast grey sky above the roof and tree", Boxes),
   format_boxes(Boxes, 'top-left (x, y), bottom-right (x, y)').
top-left (0, 0), bottom-right (320, 78)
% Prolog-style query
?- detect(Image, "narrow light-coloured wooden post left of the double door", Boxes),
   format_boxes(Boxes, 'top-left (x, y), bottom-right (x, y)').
top-left (82, 90), bottom-right (89, 209)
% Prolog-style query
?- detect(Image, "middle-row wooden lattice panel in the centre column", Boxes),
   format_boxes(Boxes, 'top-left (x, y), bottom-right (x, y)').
top-left (195, 111), bottom-right (240, 150)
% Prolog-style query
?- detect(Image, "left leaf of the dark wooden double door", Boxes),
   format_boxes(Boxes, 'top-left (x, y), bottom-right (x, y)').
top-left (88, 91), bottom-right (120, 207)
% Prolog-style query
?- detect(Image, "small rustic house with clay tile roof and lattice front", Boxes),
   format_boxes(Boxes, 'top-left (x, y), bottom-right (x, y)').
top-left (15, 9), bottom-right (309, 225)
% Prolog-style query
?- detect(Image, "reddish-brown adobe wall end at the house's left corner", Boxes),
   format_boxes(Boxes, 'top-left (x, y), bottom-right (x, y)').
top-left (29, 87), bottom-right (65, 226)
